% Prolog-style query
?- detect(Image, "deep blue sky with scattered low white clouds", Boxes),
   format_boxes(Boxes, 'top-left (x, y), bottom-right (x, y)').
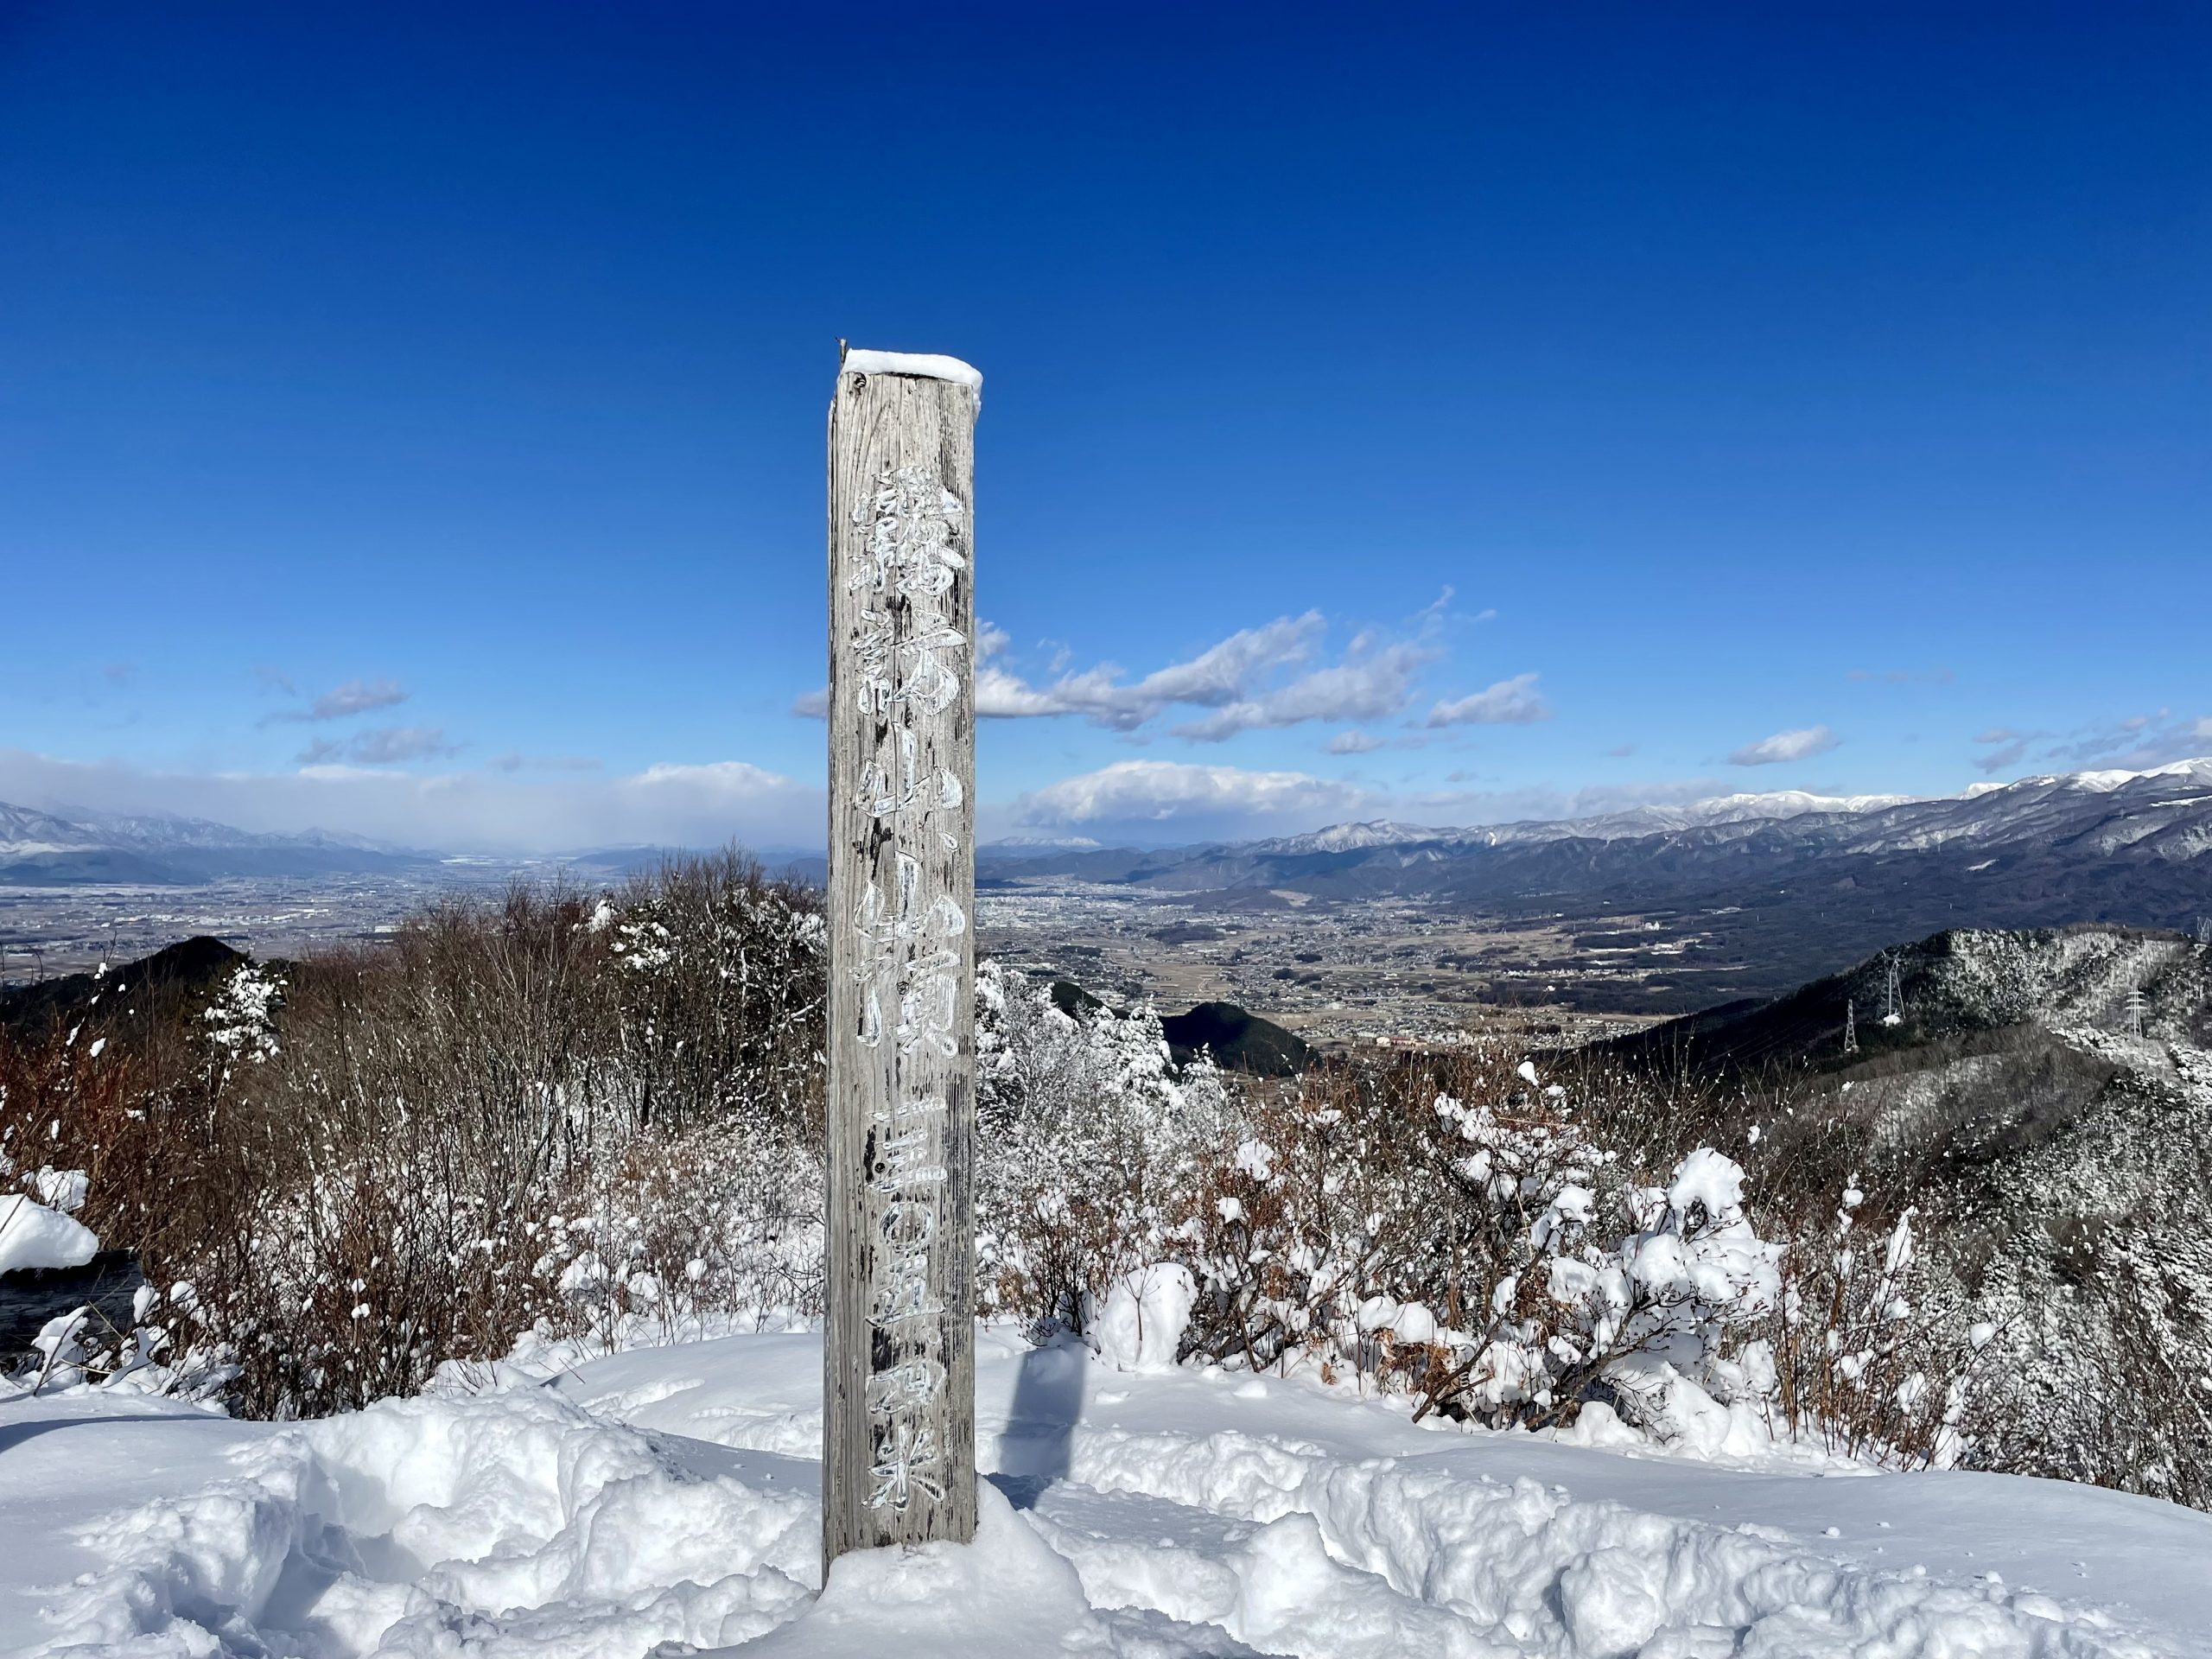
top-left (0, 0), bottom-right (2212, 845)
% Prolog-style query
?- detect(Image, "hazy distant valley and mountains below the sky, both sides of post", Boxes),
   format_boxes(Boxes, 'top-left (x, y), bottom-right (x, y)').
top-left (0, 759), bottom-right (2212, 1046)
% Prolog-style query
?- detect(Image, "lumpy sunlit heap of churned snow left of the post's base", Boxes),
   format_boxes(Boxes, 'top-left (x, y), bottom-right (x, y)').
top-left (27, 1391), bottom-right (818, 1659)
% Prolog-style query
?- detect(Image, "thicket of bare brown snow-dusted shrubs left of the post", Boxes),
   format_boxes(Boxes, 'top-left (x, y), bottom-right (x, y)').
top-left (0, 856), bottom-right (823, 1415)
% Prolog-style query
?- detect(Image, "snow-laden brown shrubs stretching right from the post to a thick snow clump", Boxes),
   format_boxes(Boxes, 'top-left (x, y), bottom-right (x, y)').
top-left (978, 1021), bottom-right (1778, 1422)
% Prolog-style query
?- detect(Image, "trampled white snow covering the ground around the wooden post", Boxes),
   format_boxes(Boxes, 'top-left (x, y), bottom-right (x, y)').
top-left (0, 1330), bottom-right (2212, 1659)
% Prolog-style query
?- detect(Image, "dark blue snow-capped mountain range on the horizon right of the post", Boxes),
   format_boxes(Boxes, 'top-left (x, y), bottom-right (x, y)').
top-left (978, 759), bottom-right (2212, 1007)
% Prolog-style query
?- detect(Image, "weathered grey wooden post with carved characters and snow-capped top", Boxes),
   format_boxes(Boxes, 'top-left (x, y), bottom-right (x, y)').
top-left (823, 352), bottom-right (982, 1571)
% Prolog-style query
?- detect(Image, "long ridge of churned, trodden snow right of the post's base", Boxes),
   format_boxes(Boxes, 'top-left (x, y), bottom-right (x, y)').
top-left (1042, 1433), bottom-right (2161, 1659)
